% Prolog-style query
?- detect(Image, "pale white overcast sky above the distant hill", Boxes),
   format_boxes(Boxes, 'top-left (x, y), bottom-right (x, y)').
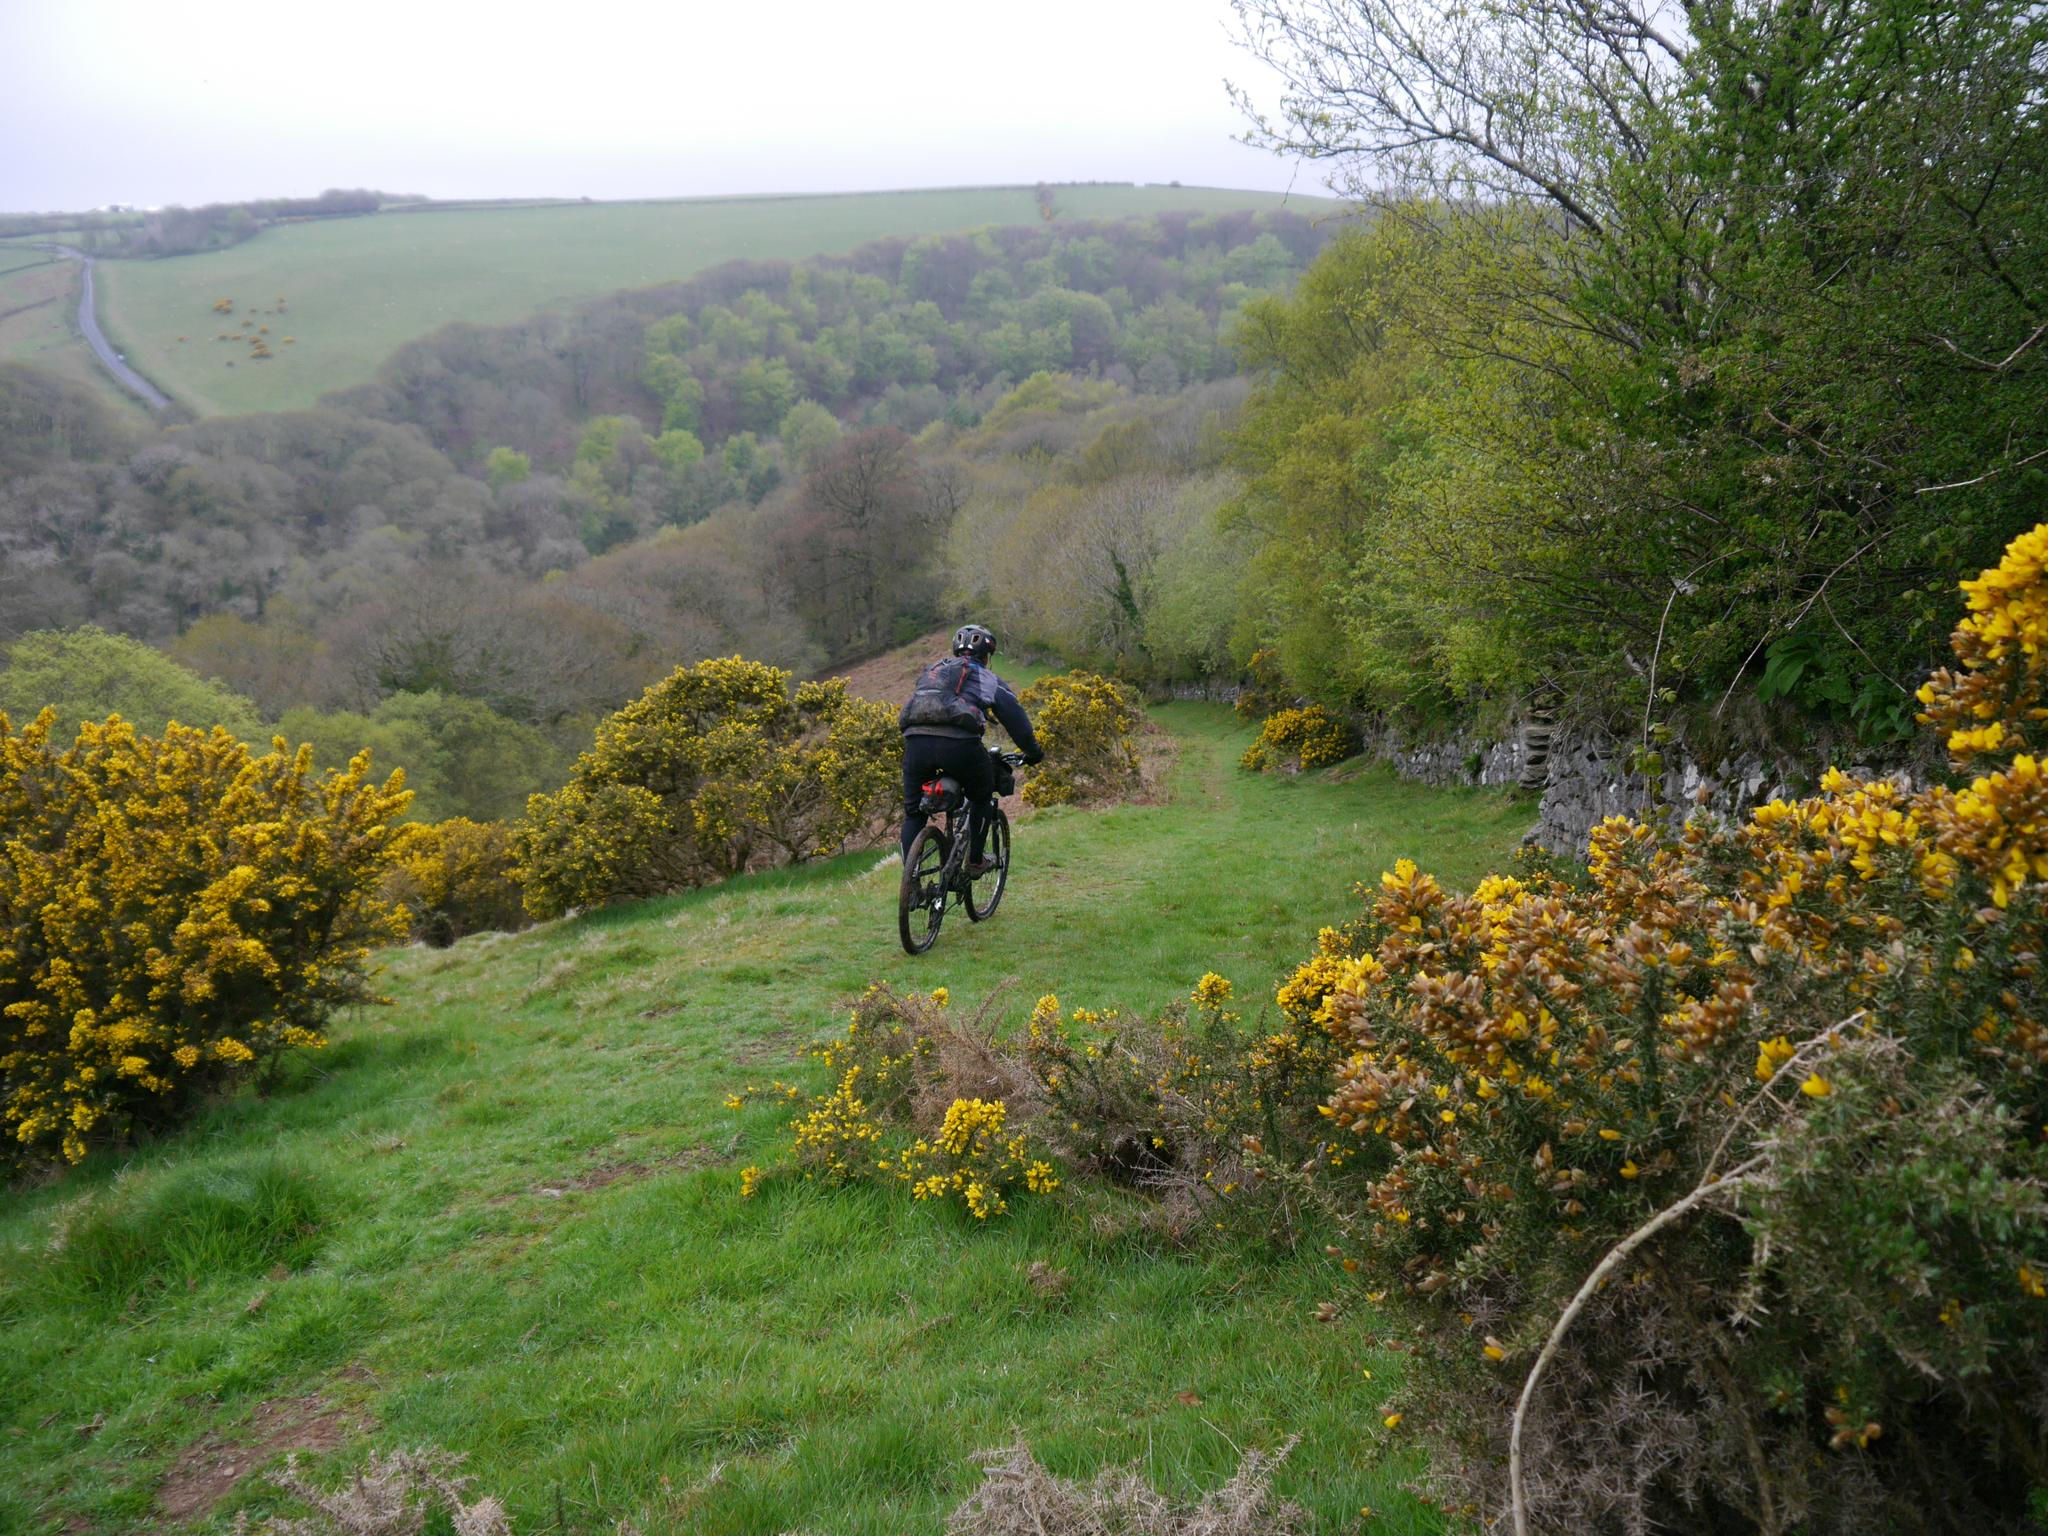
top-left (0, 0), bottom-right (1321, 211)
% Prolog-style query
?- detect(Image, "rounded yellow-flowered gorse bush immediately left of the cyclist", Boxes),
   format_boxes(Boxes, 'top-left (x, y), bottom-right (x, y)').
top-left (516, 655), bottom-right (901, 918)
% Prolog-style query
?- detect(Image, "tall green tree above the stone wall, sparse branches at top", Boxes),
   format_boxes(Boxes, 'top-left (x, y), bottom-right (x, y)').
top-left (1235, 0), bottom-right (2048, 735)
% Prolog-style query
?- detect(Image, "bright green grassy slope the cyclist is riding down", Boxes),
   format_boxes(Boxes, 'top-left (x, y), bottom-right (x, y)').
top-left (0, 705), bottom-right (1526, 1536)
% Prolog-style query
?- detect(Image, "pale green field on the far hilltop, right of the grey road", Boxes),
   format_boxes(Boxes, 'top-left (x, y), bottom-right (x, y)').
top-left (98, 186), bottom-right (1337, 414)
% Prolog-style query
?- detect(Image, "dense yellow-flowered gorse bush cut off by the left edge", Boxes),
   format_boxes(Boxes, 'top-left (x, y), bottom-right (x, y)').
top-left (0, 711), bottom-right (410, 1163)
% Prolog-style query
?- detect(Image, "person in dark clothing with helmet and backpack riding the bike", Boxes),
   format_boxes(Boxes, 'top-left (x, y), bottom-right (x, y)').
top-left (897, 625), bottom-right (1044, 877)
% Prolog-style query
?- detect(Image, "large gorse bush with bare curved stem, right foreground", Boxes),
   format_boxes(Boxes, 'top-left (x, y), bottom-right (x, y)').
top-left (1282, 526), bottom-right (2048, 1534)
